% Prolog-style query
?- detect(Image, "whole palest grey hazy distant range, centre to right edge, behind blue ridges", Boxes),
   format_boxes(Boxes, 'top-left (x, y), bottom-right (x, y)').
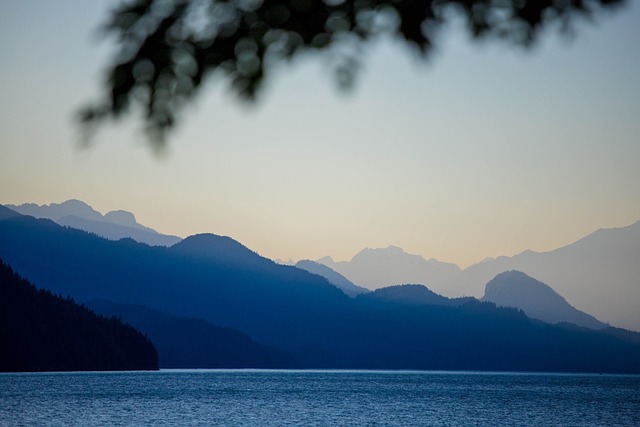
top-left (318, 221), bottom-right (640, 331)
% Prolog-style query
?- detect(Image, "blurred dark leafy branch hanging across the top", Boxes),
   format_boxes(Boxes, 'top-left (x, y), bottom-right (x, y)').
top-left (81, 0), bottom-right (623, 145)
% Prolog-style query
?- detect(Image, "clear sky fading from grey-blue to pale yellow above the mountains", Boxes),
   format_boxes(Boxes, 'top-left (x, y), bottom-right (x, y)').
top-left (0, 0), bottom-right (640, 267)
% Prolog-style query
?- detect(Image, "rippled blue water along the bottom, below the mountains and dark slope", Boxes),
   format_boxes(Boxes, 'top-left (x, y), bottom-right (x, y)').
top-left (0, 370), bottom-right (640, 426)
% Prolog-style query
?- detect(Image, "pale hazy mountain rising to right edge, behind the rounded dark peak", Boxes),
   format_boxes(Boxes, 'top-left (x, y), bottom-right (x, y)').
top-left (455, 221), bottom-right (640, 331)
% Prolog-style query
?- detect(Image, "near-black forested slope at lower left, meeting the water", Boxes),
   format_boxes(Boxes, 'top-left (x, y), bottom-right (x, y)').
top-left (0, 260), bottom-right (158, 372)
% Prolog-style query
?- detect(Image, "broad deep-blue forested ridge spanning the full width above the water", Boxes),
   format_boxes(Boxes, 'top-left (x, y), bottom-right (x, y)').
top-left (0, 208), bottom-right (640, 373)
